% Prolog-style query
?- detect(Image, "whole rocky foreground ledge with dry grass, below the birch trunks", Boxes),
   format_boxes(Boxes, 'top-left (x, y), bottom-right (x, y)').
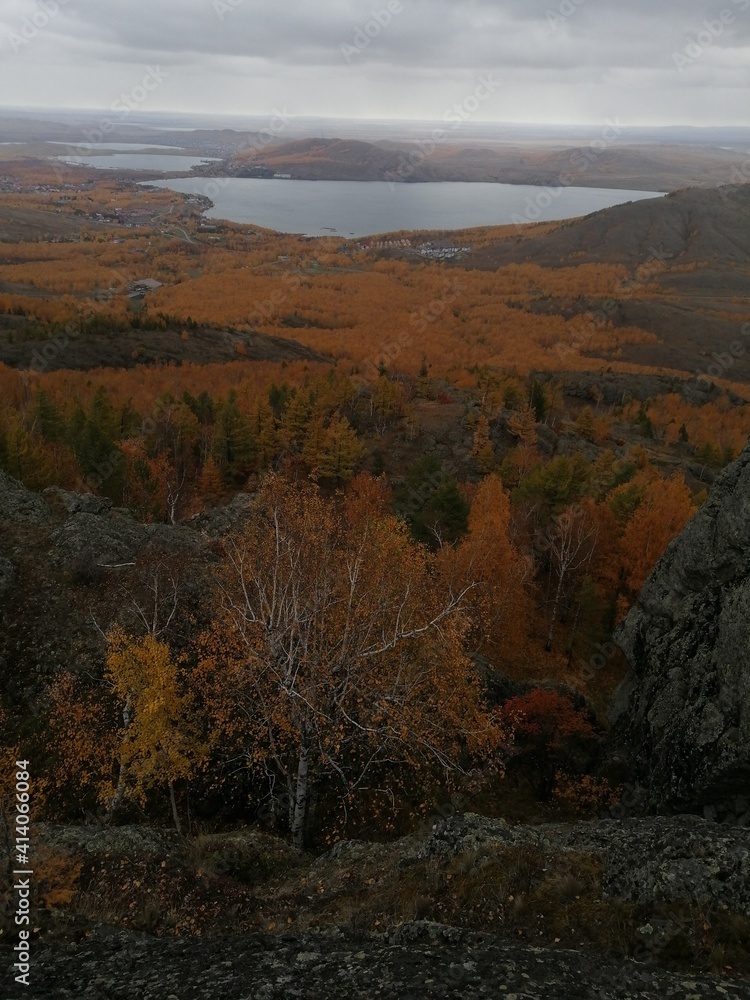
top-left (0, 813), bottom-right (750, 1000)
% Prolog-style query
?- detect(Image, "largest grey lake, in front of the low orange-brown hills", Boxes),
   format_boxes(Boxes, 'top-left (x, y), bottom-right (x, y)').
top-left (142, 176), bottom-right (661, 238)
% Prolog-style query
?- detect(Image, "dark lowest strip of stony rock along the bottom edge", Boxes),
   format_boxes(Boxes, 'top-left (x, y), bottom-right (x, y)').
top-left (4, 922), bottom-right (750, 1000)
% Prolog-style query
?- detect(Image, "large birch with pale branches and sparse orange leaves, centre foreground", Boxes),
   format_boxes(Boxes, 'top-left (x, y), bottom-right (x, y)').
top-left (198, 476), bottom-right (500, 849)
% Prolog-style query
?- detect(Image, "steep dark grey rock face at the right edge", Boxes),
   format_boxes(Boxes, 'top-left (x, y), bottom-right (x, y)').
top-left (607, 447), bottom-right (750, 823)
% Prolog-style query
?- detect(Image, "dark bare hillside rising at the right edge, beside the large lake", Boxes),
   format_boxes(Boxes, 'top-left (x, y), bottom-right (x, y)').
top-left (449, 184), bottom-right (750, 381)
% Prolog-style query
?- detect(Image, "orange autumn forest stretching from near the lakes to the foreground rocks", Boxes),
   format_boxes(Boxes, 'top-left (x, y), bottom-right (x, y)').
top-left (0, 161), bottom-right (750, 851)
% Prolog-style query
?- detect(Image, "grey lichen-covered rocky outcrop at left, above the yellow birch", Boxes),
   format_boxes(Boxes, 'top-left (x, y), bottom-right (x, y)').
top-left (0, 473), bottom-right (238, 704)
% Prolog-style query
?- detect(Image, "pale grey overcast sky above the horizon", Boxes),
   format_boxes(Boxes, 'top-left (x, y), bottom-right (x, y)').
top-left (0, 0), bottom-right (750, 125)
